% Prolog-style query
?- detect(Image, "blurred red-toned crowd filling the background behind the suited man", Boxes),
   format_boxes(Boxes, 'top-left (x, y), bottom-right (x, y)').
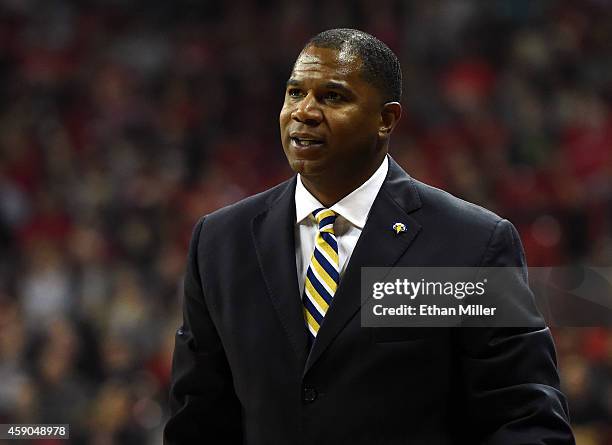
top-left (0, 0), bottom-right (612, 445)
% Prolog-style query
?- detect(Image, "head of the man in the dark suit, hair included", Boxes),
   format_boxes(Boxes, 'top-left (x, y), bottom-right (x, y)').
top-left (279, 29), bottom-right (401, 201)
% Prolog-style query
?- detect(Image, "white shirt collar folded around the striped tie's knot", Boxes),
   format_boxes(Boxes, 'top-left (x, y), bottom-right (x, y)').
top-left (295, 156), bottom-right (389, 229)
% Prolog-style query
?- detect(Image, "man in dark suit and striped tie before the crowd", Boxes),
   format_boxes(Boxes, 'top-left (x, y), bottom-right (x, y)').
top-left (165, 29), bottom-right (573, 445)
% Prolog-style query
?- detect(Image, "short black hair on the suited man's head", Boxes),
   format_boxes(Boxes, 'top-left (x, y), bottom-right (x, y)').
top-left (302, 28), bottom-right (402, 102)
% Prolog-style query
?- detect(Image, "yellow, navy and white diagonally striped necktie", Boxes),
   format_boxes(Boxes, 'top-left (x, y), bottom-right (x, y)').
top-left (303, 208), bottom-right (340, 345)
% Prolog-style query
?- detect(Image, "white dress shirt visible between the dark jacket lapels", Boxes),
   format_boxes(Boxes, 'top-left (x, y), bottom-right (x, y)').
top-left (295, 156), bottom-right (389, 295)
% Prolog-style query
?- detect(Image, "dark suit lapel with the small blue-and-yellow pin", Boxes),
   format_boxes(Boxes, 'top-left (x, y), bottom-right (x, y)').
top-left (304, 158), bottom-right (421, 373)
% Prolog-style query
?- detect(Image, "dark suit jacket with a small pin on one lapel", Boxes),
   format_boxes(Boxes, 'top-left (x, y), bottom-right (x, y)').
top-left (164, 159), bottom-right (573, 445)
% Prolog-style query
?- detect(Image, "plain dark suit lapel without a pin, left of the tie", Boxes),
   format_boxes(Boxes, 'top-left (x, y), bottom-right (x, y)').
top-left (252, 177), bottom-right (308, 365)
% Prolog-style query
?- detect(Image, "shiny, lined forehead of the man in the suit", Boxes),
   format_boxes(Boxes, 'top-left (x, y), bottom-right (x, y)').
top-left (291, 46), bottom-right (361, 82)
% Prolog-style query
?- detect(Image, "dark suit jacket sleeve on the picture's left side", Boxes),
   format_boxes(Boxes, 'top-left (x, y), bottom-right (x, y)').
top-left (164, 218), bottom-right (242, 445)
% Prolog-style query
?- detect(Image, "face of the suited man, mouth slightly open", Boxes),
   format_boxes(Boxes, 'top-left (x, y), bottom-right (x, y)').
top-left (279, 46), bottom-right (382, 182)
